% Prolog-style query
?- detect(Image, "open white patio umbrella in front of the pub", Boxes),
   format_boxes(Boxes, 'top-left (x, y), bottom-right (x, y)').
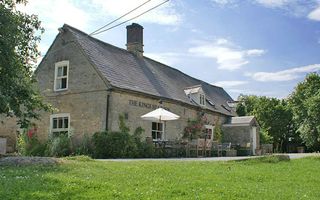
top-left (141, 108), bottom-right (180, 139)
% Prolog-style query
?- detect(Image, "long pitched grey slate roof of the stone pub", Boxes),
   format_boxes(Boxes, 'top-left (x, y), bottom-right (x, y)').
top-left (63, 24), bottom-right (235, 116)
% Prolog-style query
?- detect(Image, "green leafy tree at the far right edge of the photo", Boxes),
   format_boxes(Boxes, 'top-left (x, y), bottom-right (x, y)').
top-left (289, 73), bottom-right (320, 150)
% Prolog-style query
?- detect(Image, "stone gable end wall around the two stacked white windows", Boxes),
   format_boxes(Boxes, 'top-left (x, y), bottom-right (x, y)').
top-left (36, 28), bottom-right (108, 143)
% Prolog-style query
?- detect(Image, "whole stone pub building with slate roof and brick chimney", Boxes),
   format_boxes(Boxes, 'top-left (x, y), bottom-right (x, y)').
top-left (0, 23), bottom-right (257, 155)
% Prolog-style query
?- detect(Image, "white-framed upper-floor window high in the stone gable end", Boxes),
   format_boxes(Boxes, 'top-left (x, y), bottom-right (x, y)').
top-left (54, 60), bottom-right (69, 91)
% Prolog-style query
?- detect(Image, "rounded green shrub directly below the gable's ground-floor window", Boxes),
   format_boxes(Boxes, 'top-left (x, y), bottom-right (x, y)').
top-left (47, 134), bottom-right (72, 157)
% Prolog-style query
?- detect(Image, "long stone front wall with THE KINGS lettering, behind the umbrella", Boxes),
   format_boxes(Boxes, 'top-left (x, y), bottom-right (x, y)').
top-left (109, 92), bottom-right (226, 140)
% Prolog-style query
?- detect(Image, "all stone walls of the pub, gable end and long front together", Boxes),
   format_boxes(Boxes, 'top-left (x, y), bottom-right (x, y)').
top-left (0, 27), bottom-right (235, 151)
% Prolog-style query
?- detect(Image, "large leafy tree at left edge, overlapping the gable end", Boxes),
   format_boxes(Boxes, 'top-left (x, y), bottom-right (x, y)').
top-left (0, 0), bottom-right (50, 128)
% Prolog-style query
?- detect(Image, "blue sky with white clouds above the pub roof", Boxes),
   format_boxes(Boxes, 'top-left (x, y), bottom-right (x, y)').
top-left (17, 0), bottom-right (320, 100)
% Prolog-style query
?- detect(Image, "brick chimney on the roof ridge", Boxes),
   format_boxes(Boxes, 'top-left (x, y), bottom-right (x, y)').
top-left (126, 23), bottom-right (143, 57)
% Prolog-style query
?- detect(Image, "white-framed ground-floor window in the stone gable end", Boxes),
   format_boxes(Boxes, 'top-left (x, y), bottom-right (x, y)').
top-left (50, 113), bottom-right (70, 136)
